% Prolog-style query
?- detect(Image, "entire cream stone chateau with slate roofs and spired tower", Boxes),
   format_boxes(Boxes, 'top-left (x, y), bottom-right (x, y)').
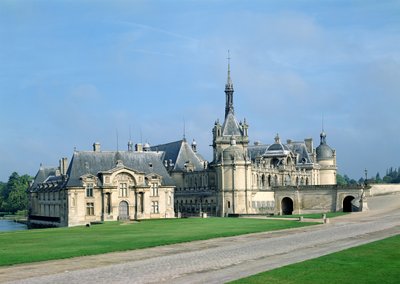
top-left (29, 64), bottom-right (340, 227)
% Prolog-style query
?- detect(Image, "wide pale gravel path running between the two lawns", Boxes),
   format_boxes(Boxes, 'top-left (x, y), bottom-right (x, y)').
top-left (0, 195), bottom-right (400, 284)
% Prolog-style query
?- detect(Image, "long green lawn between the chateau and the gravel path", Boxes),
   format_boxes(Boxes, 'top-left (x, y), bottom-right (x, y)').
top-left (0, 218), bottom-right (315, 266)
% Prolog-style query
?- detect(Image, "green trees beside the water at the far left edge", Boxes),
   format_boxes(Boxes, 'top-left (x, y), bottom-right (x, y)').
top-left (0, 172), bottom-right (33, 213)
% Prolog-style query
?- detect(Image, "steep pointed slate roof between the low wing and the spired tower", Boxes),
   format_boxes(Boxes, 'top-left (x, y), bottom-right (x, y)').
top-left (151, 139), bottom-right (205, 171)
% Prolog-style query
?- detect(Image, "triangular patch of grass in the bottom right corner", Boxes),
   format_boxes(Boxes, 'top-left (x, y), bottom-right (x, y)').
top-left (231, 235), bottom-right (400, 284)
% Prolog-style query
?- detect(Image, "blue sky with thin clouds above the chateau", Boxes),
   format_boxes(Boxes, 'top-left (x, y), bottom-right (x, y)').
top-left (0, 0), bottom-right (400, 181)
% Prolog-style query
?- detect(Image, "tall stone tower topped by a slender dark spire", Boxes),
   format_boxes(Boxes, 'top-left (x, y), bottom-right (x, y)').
top-left (212, 57), bottom-right (251, 216)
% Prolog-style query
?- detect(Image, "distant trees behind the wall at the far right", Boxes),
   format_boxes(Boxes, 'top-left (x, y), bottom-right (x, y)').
top-left (336, 167), bottom-right (400, 185)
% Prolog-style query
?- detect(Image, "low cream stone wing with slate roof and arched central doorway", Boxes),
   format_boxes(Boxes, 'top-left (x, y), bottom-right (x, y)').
top-left (29, 144), bottom-right (175, 227)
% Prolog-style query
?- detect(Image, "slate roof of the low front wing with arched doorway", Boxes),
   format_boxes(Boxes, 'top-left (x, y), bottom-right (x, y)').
top-left (67, 151), bottom-right (174, 186)
